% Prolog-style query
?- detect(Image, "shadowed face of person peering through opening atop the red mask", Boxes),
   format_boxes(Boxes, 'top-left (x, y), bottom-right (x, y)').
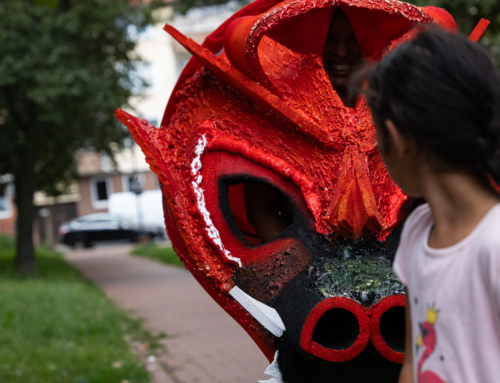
top-left (323, 9), bottom-right (363, 103)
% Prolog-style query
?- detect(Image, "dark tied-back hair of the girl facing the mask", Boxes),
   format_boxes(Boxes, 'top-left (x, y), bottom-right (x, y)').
top-left (367, 30), bottom-right (500, 184)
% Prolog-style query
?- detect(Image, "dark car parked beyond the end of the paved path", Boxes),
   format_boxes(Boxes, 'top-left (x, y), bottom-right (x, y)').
top-left (59, 213), bottom-right (163, 248)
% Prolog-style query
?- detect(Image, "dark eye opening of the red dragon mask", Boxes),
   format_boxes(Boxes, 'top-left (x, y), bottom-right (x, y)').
top-left (221, 180), bottom-right (293, 245)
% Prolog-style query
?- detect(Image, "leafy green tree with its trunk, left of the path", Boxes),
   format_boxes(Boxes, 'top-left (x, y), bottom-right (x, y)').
top-left (0, 0), bottom-right (158, 274)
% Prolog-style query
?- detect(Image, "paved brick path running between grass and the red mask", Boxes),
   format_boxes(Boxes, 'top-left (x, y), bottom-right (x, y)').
top-left (67, 246), bottom-right (269, 383)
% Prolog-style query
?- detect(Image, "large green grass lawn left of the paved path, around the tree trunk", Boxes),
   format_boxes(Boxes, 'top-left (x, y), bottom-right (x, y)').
top-left (0, 236), bottom-right (156, 383)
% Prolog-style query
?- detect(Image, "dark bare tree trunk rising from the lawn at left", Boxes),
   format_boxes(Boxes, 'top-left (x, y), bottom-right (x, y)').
top-left (14, 153), bottom-right (35, 276)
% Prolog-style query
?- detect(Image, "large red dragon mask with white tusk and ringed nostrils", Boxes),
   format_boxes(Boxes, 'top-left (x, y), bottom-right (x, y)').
top-left (116, 0), bottom-right (482, 383)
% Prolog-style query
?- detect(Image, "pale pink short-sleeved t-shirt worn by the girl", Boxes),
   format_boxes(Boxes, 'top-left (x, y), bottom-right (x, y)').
top-left (394, 204), bottom-right (500, 383)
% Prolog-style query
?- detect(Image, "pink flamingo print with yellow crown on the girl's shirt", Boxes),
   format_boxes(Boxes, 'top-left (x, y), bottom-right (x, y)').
top-left (417, 306), bottom-right (447, 383)
